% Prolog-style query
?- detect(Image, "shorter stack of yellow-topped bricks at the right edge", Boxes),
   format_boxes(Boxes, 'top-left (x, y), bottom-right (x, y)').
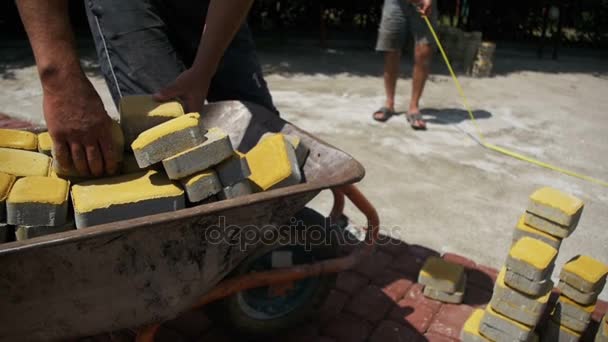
top-left (543, 255), bottom-right (608, 341)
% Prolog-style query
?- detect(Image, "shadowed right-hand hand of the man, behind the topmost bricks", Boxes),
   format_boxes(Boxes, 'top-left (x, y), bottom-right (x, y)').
top-left (154, 68), bottom-right (212, 113)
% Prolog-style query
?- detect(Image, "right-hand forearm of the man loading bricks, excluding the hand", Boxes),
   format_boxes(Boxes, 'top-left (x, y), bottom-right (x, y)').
top-left (193, 0), bottom-right (253, 75)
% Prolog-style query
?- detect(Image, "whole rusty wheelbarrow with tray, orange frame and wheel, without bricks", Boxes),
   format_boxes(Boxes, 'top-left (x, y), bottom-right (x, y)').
top-left (0, 101), bottom-right (379, 341)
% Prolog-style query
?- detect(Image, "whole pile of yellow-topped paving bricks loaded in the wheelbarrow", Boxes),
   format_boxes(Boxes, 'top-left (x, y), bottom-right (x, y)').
top-left (0, 95), bottom-right (308, 243)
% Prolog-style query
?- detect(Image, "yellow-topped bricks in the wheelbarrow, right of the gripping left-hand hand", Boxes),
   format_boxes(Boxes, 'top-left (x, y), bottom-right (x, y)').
top-left (72, 96), bottom-right (308, 228)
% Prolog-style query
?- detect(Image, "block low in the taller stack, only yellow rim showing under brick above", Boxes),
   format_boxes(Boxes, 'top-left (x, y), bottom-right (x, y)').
top-left (490, 268), bottom-right (552, 326)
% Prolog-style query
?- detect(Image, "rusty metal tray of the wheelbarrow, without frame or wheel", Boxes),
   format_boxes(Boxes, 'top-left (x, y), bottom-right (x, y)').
top-left (0, 101), bottom-right (364, 341)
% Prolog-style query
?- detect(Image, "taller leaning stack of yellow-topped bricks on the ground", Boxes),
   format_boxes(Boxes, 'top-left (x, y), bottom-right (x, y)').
top-left (461, 188), bottom-right (583, 341)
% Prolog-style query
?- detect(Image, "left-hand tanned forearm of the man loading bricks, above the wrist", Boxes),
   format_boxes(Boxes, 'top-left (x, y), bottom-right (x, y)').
top-left (16, 0), bottom-right (83, 91)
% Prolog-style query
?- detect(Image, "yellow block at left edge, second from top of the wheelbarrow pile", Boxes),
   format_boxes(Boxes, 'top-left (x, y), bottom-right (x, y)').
top-left (0, 147), bottom-right (51, 177)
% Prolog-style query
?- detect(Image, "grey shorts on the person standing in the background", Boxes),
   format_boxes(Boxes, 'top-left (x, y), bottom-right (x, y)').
top-left (376, 0), bottom-right (437, 51)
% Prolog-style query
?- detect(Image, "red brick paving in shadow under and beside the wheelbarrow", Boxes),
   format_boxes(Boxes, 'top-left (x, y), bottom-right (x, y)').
top-left (0, 113), bottom-right (608, 342)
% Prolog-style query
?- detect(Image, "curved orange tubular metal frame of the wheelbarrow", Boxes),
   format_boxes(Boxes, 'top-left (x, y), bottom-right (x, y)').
top-left (136, 184), bottom-right (380, 342)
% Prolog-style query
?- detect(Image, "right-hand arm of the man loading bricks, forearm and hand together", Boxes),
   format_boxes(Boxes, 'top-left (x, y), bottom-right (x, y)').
top-left (155, 0), bottom-right (253, 112)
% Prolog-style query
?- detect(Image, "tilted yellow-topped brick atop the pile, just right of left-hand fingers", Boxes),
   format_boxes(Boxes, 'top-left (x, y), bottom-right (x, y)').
top-left (131, 113), bottom-right (206, 169)
